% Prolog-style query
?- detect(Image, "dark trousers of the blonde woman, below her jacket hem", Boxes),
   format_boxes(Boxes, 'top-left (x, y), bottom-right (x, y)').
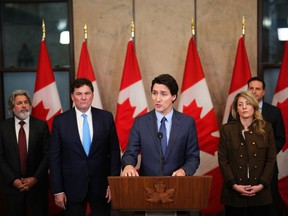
top-left (225, 205), bottom-right (272, 216)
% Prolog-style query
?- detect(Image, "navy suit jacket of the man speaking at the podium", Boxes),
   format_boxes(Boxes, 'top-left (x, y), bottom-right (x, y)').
top-left (122, 110), bottom-right (200, 176)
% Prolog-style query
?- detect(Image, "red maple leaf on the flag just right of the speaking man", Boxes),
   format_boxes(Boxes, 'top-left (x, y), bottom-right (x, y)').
top-left (183, 100), bottom-right (219, 155)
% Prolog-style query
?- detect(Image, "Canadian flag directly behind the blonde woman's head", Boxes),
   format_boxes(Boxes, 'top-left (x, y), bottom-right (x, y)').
top-left (222, 36), bottom-right (251, 124)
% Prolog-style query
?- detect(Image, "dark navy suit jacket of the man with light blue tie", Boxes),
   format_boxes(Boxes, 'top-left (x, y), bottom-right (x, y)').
top-left (50, 107), bottom-right (121, 202)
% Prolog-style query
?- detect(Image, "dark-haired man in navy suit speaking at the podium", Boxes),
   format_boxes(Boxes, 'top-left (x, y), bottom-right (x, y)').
top-left (122, 74), bottom-right (200, 176)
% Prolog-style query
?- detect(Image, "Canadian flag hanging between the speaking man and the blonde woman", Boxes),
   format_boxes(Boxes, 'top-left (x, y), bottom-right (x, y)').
top-left (178, 37), bottom-right (223, 215)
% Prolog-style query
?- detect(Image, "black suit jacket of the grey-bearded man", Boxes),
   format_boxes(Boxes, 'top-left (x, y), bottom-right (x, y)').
top-left (0, 116), bottom-right (50, 195)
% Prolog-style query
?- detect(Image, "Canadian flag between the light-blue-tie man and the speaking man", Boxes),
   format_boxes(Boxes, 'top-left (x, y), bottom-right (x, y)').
top-left (115, 39), bottom-right (148, 152)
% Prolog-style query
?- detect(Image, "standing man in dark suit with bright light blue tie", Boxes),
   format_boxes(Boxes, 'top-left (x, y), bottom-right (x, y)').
top-left (50, 78), bottom-right (121, 216)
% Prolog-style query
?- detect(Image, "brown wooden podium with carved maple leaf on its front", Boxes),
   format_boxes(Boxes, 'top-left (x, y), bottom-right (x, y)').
top-left (108, 176), bottom-right (212, 211)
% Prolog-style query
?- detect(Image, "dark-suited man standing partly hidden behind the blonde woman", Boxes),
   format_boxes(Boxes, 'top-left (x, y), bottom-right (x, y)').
top-left (228, 77), bottom-right (286, 216)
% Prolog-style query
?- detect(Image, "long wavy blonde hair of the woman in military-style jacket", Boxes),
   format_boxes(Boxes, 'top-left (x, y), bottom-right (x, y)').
top-left (232, 91), bottom-right (266, 136)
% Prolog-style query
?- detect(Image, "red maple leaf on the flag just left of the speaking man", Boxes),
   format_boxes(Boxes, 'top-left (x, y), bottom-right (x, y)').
top-left (116, 98), bottom-right (148, 152)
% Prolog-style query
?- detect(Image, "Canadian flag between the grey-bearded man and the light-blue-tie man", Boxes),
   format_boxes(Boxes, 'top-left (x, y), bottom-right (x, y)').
top-left (32, 40), bottom-right (62, 132)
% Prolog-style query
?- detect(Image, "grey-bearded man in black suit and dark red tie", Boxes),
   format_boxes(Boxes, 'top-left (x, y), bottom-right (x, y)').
top-left (0, 90), bottom-right (50, 216)
